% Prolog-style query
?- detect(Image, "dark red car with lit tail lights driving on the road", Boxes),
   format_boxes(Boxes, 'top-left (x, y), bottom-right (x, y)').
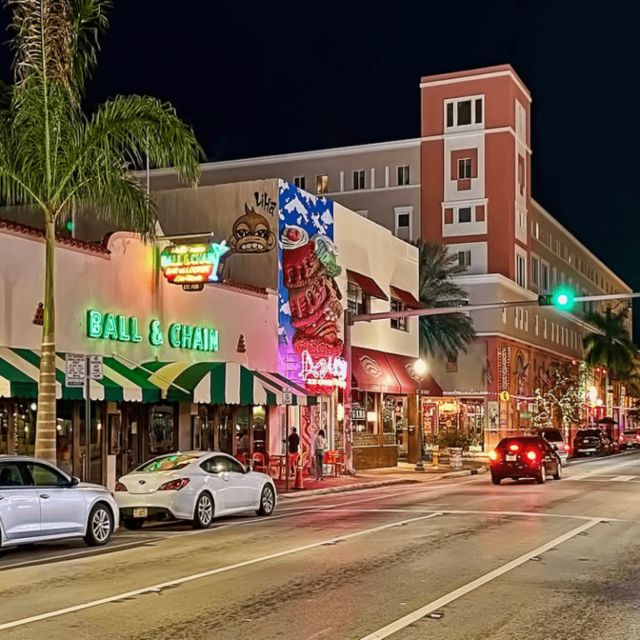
top-left (489, 436), bottom-right (562, 484)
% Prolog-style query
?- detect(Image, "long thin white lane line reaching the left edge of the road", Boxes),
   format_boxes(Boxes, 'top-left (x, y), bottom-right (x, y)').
top-left (0, 513), bottom-right (440, 631)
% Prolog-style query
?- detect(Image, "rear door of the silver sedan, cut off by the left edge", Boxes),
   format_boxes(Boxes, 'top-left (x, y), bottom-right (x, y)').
top-left (0, 460), bottom-right (40, 540)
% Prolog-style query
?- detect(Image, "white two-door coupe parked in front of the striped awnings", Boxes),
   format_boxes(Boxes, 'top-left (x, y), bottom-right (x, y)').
top-left (115, 451), bottom-right (276, 529)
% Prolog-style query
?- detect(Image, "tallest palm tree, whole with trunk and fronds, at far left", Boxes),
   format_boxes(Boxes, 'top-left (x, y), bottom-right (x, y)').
top-left (0, 0), bottom-right (202, 462)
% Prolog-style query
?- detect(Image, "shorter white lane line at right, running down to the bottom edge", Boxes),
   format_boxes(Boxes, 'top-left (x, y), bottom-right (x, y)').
top-left (361, 518), bottom-right (600, 640)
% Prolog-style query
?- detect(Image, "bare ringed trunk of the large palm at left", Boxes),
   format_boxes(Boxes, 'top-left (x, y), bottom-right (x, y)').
top-left (35, 219), bottom-right (56, 464)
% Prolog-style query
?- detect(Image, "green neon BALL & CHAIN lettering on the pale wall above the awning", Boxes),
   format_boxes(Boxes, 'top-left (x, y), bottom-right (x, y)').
top-left (87, 309), bottom-right (219, 352)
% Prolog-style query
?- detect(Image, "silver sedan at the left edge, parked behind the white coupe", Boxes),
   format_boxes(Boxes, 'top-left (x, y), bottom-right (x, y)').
top-left (0, 455), bottom-right (118, 547)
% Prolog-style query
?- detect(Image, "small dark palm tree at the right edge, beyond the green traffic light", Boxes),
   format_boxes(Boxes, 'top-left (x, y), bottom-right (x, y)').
top-left (582, 307), bottom-right (638, 389)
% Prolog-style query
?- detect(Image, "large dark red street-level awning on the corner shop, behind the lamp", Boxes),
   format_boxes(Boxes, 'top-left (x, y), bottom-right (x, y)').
top-left (351, 347), bottom-right (442, 396)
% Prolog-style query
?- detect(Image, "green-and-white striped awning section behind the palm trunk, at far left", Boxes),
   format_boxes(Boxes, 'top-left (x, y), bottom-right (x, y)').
top-left (0, 347), bottom-right (161, 402)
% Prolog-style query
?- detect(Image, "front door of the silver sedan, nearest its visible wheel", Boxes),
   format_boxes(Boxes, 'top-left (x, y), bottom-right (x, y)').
top-left (24, 462), bottom-right (87, 536)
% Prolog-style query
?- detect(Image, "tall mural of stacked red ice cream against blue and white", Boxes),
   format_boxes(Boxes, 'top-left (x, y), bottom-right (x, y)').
top-left (278, 180), bottom-right (346, 393)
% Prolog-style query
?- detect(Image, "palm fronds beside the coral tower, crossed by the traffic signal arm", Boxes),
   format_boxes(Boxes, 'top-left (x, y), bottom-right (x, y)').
top-left (418, 241), bottom-right (475, 358)
